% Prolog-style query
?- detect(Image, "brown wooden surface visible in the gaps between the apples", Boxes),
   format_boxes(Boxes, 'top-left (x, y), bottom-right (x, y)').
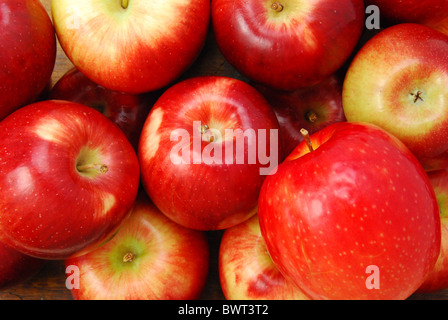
top-left (0, 0), bottom-right (448, 300)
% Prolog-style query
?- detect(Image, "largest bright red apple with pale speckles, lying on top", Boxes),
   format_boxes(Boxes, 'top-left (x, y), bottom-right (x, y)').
top-left (259, 123), bottom-right (441, 300)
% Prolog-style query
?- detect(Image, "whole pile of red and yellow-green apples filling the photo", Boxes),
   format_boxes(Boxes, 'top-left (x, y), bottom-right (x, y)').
top-left (0, 0), bottom-right (448, 300)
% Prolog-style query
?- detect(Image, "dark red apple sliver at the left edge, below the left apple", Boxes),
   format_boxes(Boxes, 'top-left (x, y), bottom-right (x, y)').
top-left (0, 243), bottom-right (45, 289)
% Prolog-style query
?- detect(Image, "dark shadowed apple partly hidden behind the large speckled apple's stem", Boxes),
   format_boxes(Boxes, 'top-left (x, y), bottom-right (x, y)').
top-left (254, 74), bottom-right (346, 156)
